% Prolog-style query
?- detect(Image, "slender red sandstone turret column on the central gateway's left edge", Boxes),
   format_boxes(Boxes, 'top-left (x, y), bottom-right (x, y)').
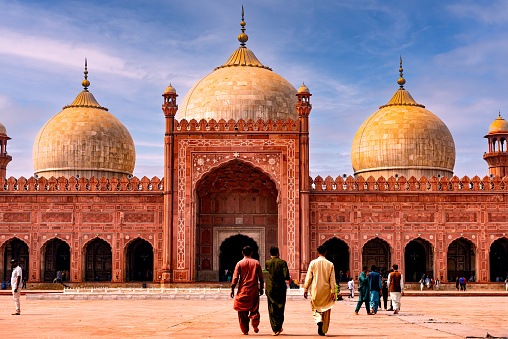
top-left (161, 84), bottom-right (178, 286)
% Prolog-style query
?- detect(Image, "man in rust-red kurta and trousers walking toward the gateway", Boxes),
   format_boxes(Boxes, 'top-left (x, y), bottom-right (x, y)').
top-left (231, 246), bottom-right (263, 334)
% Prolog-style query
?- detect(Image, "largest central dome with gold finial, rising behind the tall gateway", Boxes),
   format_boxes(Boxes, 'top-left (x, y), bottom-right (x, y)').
top-left (177, 7), bottom-right (298, 121)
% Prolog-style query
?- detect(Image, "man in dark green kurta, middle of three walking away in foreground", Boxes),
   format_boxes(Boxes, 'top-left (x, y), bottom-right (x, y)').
top-left (266, 246), bottom-right (289, 335)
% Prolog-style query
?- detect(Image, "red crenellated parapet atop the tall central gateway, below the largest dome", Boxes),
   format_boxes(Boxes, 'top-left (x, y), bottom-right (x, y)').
top-left (175, 119), bottom-right (300, 132)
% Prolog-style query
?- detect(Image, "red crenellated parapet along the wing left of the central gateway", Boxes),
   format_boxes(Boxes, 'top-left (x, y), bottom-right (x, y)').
top-left (0, 177), bottom-right (164, 192)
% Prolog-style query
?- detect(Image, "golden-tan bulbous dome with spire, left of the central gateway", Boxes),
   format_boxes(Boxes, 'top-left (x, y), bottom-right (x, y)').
top-left (33, 62), bottom-right (136, 178)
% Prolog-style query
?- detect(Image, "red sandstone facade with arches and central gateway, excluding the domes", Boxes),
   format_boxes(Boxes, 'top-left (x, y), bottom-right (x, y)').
top-left (0, 92), bottom-right (508, 284)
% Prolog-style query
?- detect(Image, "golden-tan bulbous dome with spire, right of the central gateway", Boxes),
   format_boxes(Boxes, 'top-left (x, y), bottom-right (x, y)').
top-left (351, 59), bottom-right (455, 179)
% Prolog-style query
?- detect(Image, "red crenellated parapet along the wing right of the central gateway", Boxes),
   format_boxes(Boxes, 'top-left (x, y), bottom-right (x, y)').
top-left (309, 176), bottom-right (508, 192)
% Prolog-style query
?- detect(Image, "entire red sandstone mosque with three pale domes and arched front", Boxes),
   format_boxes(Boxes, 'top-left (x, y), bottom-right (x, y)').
top-left (0, 13), bottom-right (508, 284)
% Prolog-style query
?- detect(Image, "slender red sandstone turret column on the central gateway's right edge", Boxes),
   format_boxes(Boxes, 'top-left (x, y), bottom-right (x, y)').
top-left (296, 84), bottom-right (312, 280)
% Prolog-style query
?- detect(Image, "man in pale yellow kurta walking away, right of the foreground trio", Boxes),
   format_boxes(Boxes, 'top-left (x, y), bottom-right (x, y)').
top-left (303, 246), bottom-right (335, 335)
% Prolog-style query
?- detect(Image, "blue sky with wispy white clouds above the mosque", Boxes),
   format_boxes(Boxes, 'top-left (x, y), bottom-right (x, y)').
top-left (0, 0), bottom-right (508, 178)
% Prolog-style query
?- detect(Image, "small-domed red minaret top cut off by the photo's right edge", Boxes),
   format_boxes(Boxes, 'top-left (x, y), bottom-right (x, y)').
top-left (483, 111), bottom-right (508, 178)
